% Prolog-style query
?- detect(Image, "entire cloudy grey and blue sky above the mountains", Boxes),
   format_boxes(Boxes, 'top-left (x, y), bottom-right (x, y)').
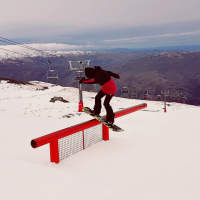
top-left (0, 0), bottom-right (200, 50)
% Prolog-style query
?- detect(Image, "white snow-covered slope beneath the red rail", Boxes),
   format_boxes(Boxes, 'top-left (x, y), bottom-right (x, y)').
top-left (0, 81), bottom-right (200, 200)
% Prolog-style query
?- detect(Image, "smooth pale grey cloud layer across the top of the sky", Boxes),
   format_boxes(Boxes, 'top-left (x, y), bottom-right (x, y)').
top-left (0, 0), bottom-right (200, 35)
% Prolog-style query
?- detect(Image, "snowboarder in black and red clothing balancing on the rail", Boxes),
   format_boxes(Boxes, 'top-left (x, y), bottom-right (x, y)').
top-left (79, 66), bottom-right (120, 124)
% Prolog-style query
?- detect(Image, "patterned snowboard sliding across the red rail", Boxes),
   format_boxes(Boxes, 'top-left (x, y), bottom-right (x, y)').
top-left (82, 107), bottom-right (124, 132)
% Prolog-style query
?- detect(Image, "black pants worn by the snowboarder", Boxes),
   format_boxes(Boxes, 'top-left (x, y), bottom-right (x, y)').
top-left (94, 90), bottom-right (115, 121)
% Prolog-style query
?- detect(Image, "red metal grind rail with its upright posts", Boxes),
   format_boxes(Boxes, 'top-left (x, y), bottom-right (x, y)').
top-left (31, 103), bottom-right (147, 163)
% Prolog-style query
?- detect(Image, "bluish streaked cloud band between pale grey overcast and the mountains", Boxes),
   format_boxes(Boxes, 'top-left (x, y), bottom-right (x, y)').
top-left (0, 20), bottom-right (200, 51)
